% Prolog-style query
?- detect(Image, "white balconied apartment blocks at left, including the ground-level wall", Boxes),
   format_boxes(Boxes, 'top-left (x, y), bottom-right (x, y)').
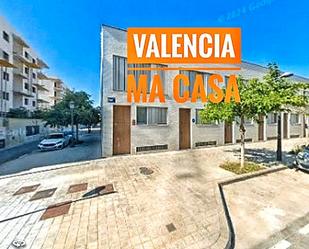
top-left (0, 16), bottom-right (65, 149)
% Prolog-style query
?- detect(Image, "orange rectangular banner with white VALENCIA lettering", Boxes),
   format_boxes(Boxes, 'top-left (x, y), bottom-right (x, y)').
top-left (127, 28), bottom-right (241, 64)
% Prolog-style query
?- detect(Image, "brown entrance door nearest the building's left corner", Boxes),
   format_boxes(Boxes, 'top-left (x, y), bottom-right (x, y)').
top-left (113, 105), bottom-right (131, 155)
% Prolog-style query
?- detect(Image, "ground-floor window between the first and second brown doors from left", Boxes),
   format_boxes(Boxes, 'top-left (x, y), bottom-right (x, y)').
top-left (136, 106), bottom-right (167, 125)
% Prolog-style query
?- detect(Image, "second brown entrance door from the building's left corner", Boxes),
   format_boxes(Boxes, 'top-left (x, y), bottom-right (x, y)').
top-left (179, 109), bottom-right (191, 150)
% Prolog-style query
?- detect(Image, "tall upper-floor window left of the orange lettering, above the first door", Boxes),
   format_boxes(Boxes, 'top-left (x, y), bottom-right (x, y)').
top-left (113, 55), bottom-right (128, 91)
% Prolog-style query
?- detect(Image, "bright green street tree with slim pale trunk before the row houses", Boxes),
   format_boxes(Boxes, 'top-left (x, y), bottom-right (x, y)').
top-left (201, 64), bottom-right (308, 167)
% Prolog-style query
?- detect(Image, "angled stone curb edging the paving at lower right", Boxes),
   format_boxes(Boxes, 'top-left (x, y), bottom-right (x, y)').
top-left (218, 165), bottom-right (288, 249)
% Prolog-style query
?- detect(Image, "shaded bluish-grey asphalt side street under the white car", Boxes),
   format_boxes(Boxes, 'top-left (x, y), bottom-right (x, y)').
top-left (0, 131), bottom-right (101, 175)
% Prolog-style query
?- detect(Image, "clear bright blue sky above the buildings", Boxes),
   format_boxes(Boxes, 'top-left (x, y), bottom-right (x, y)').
top-left (0, 0), bottom-right (309, 105)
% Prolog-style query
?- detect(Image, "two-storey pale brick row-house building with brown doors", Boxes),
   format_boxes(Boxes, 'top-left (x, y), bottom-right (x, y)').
top-left (101, 25), bottom-right (309, 157)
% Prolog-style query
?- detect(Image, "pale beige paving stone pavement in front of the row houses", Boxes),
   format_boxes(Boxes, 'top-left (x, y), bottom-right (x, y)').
top-left (0, 139), bottom-right (304, 249)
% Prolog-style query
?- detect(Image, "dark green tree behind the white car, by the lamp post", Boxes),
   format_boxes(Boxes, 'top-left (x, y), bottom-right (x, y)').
top-left (43, 90), bottom-right (96, 141)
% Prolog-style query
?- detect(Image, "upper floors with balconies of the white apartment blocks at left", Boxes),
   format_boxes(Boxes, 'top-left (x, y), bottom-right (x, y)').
top-left (0, 16), bottom-right (65, 114)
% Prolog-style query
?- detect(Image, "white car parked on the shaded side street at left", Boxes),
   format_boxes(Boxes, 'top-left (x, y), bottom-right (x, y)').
top-left (38, 133), bottom-right (70, 151)
